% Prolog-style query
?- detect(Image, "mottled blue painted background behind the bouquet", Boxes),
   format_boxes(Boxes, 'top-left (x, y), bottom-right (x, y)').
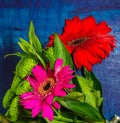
top-left (0, 0), bottom-right (120, 120)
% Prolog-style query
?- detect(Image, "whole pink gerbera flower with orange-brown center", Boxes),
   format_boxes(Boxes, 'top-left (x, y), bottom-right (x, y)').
top-left (20, 59), bottom-right (75, 120)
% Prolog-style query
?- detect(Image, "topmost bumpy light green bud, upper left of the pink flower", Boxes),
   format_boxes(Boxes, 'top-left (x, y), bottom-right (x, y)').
top-left (15, 57), bottom-right (38, 78)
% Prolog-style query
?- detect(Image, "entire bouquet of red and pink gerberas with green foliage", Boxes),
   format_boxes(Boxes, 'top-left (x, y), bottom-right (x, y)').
top-left (0, 16), bottom-right (119, 123)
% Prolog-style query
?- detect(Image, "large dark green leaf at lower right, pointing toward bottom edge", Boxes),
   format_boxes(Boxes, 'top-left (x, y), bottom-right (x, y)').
top-left (59, 98), bottom-right (104, 123)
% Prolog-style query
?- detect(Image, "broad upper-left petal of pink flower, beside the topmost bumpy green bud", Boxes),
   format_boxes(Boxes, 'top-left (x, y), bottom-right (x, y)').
top-left (32, 65), bottom-right (47, 82)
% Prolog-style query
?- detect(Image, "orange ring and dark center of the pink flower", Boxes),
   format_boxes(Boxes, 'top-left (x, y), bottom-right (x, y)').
top-left (38, 78), bottom-right (55, 96)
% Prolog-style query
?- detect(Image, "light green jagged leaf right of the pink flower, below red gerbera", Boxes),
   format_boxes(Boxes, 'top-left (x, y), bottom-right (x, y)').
top-left (77, 76), bottom-right (102, 109)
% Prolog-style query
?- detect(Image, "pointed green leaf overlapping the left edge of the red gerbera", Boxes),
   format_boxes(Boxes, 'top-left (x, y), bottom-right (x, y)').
top-left (53, 34), bottom-right (73, 68)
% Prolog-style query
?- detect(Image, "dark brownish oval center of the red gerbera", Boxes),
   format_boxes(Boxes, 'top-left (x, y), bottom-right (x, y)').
top-left (67, 37), bottom-right (89, 46)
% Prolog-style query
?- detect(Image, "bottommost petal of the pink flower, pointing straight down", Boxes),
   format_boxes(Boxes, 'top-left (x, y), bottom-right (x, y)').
top-left (42, 102), bottom-right (54, 121)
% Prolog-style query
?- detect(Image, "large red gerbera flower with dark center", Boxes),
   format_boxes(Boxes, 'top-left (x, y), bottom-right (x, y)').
top-left (47, 16), bottom-right (116, 71)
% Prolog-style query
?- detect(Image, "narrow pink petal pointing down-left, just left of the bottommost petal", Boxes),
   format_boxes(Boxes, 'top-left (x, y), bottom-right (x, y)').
top-left (32, 101), bottom-right (41, 118)
